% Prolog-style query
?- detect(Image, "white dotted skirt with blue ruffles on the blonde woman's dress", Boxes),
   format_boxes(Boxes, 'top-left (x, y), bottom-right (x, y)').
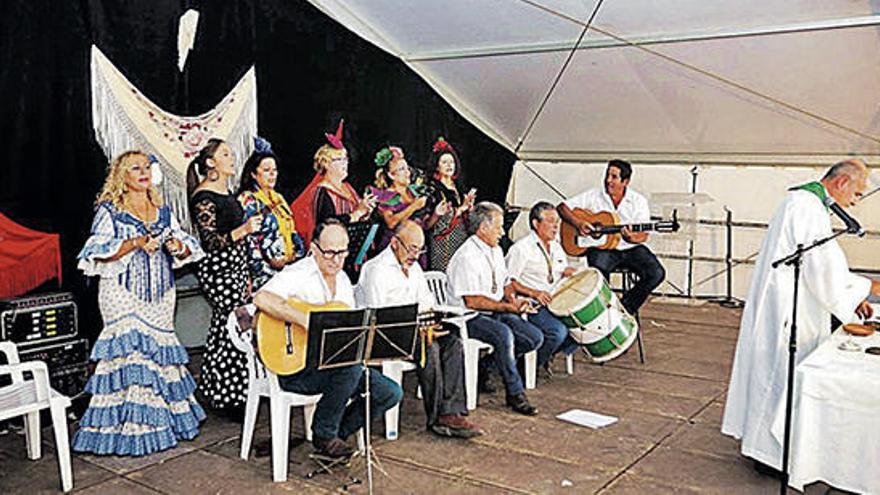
top-left (73, 280), bottom-right (205, 456)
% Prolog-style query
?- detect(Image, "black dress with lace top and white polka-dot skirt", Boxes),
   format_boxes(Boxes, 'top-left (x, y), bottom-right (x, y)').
top-left (190, 190), bottom-right (250, 409)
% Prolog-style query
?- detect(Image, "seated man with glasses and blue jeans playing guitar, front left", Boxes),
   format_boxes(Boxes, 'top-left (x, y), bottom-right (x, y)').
top-left (254, 218), bottom-right (403, 457)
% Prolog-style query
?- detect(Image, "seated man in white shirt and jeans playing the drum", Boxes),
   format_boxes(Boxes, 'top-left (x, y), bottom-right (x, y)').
top-left (507, 201), bottom-right (578, 375)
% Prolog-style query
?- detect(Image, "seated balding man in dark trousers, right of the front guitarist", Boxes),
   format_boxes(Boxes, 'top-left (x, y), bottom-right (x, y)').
top-left (355, 220), bottom-right (481, 438)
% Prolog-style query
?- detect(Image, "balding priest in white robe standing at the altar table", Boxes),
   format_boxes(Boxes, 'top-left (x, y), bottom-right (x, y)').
top-left (721, 160), bottom-right (880, 473)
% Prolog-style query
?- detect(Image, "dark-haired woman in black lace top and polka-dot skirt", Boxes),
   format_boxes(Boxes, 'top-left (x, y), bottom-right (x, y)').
top-left (187, 139), bottom-right (262, 416)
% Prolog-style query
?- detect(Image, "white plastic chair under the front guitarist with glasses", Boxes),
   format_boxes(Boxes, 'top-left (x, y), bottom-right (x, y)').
top-left (226, 304), bottom-right (363, 482)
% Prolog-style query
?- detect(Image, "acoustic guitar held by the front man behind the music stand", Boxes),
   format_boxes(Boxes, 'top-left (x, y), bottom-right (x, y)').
top-left (254, 299), bottom-right (350, 375)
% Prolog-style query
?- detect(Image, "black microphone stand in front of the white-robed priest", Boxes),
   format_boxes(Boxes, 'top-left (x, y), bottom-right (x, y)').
top-left (771, 229), bottom-right (854, 495)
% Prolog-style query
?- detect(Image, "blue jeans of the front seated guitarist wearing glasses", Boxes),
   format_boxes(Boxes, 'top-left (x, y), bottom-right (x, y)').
top-left (278, 365), bottom-right (403, 440)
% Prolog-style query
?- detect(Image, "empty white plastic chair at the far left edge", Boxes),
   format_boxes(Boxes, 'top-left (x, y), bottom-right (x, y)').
top-left (0, 342), bottom-right (73, 492)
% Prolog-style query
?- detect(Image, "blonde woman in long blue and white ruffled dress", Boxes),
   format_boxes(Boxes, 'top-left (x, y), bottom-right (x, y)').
top-left (73, 151), bottom-right (205, 456)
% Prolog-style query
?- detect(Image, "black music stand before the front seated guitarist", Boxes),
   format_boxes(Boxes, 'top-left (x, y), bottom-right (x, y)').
top-left (309, 304), bottom-right (418, 494)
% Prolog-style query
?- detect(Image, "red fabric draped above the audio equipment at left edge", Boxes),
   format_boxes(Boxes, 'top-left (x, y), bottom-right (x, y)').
top-left (0, 213), bottom-right (61, 299)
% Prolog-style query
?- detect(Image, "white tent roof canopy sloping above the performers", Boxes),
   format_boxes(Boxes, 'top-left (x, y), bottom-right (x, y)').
top-left (312, 0), bottom-right (880, 159)
